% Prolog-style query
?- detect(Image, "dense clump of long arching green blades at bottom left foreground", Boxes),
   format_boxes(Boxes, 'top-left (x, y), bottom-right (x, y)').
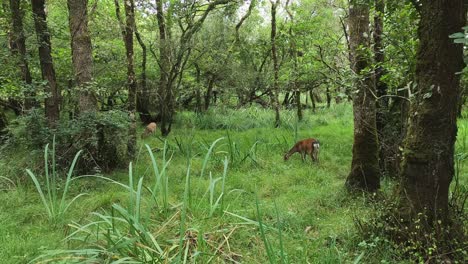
top-left (31, 163), bottom-right (166, 263)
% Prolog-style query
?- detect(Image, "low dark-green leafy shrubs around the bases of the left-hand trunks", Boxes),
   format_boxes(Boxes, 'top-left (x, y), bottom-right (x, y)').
top-left (8, 110), bottom-right (129, 173)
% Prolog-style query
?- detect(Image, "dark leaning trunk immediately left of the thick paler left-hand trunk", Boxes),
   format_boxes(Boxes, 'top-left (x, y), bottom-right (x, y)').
top-left (31, 0), bottom-right (60, 128)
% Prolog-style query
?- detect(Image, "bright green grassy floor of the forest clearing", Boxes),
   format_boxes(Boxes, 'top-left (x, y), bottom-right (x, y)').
top-left (0, 104), bottom-right (468, 263)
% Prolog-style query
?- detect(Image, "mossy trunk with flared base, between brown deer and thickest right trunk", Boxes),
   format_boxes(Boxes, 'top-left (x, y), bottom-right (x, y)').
top-left (346, 0), bottom-right (380, 192)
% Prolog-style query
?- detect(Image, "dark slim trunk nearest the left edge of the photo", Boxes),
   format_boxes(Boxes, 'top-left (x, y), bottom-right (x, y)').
top-left (10, 0), bottom-right (37, 110)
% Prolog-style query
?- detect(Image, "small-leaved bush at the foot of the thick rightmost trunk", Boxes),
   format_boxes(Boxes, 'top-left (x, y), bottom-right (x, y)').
top-left (355, 192), bottom-right (468, 263)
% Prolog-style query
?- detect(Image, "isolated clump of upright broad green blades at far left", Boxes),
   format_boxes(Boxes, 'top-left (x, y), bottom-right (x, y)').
top-left (26, 137), bottom-right (86, 223)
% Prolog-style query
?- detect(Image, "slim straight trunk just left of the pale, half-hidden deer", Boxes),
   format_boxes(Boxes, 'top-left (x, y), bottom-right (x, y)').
top-left (124, 0), bottom-right (137, 157)
